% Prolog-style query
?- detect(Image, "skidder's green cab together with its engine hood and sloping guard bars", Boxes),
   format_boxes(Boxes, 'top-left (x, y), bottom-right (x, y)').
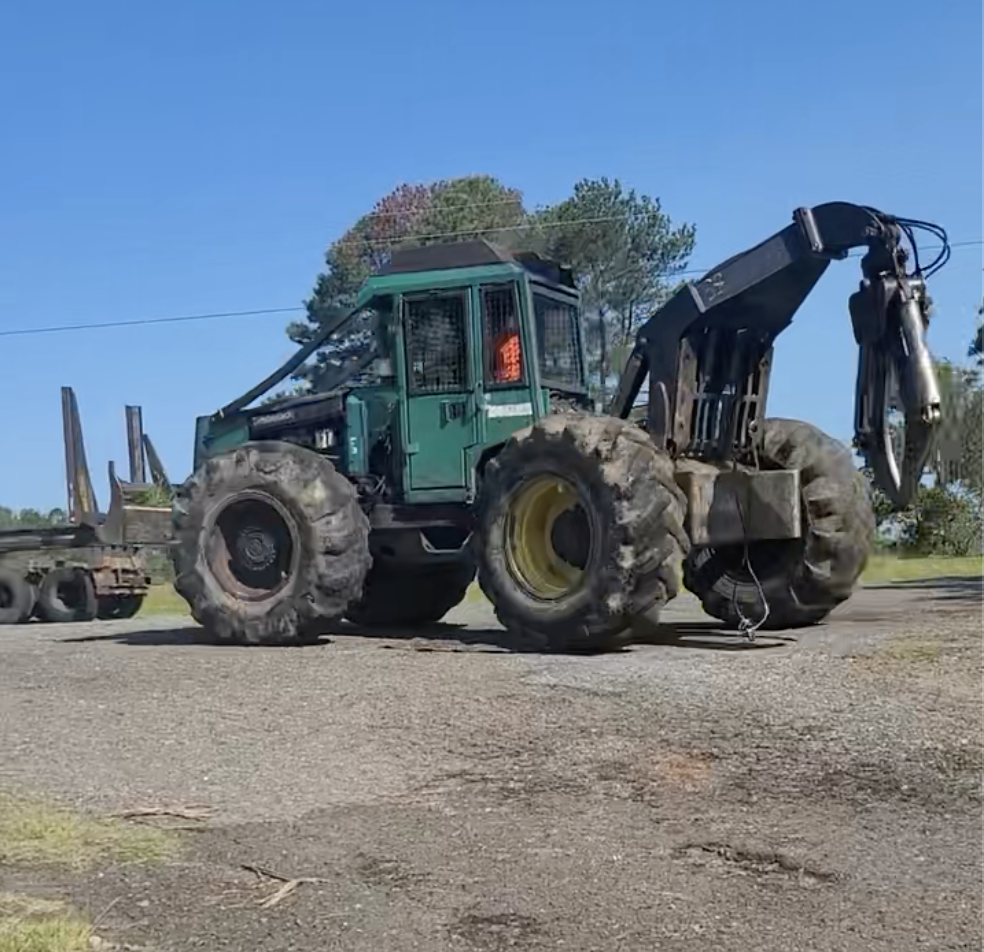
top-left (195, 241), bottom-right (589, 504)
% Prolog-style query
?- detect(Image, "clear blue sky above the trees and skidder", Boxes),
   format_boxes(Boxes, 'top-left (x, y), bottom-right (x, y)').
top-left (0, 0), bottom-right (982, 508)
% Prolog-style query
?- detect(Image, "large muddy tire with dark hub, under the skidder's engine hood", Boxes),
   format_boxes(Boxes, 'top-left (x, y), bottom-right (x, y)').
top-left (172, 441), bottom-right (371, 645)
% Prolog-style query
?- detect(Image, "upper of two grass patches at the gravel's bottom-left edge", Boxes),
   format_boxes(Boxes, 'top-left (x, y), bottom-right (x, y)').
top-left (0, 794), bottom-right (178, 872)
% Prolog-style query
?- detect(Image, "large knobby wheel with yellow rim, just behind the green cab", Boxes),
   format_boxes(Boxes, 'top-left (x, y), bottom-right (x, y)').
top-left (475, 413), bottom-right (689, 651)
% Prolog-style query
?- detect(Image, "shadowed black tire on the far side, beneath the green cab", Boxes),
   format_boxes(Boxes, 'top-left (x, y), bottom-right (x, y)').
top-left (347, 558), bottom-right (475, 628)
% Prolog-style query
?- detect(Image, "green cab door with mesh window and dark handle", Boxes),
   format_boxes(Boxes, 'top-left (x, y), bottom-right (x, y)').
top-left (402, 288), bottom-right (477, 498)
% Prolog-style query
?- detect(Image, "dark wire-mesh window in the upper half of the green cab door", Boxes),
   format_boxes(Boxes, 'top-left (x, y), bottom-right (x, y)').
top-left (403, 291), bottom-right (468, 393)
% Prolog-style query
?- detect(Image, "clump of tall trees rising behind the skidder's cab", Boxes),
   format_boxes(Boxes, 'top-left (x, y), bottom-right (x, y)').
top-left (288, 175), bottom-right (694, 398)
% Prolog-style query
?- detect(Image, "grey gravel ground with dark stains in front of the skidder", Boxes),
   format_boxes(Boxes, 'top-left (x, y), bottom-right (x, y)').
top-left (0, 580), bottom-right (982, 952)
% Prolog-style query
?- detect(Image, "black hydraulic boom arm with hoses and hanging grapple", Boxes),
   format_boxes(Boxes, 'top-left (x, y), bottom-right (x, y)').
top-left (611, 202), bottom-right (949, 508)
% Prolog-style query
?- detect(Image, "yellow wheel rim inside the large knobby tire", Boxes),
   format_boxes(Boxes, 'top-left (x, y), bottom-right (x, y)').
top-left (506, 476), bottom-right (584, 600)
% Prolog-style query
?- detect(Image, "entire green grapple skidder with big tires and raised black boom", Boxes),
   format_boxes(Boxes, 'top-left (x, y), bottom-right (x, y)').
top-left (173, 202), bottom-right (948, 650)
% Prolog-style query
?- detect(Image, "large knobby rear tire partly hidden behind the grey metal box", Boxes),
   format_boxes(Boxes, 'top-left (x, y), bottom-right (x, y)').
top-left (683, 419), bottom-right (875, 630)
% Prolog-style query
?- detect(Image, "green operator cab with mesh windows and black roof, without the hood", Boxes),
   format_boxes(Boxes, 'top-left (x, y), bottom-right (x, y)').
top-left (350, 241), bottom-right (587, 503)
